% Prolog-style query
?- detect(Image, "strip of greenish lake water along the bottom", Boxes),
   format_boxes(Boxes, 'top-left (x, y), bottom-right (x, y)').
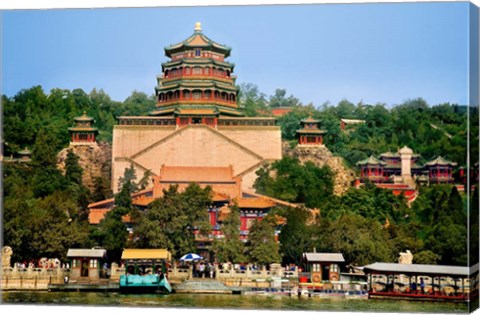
top-left (2, 291), bottom-right (468, 315)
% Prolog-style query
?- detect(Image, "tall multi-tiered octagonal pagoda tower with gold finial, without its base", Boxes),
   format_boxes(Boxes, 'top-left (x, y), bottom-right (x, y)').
top-left (151, 23), bottom-right (243, 126)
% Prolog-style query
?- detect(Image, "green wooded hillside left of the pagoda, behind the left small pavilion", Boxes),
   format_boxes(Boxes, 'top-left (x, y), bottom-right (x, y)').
top-left (2, 86), bottom-right (155, 156)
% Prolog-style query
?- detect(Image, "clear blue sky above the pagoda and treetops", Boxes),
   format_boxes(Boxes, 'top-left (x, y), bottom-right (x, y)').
top-left (2, 2), bottom-right (469, 105)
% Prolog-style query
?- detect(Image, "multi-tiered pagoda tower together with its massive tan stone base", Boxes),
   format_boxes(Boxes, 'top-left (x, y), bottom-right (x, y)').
top-left (112, 23), bottom-right (282, 192)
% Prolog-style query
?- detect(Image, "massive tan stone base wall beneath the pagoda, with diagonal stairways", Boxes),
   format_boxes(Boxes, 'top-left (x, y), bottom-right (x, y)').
top-left (112, 125), bottom-right (282, 193)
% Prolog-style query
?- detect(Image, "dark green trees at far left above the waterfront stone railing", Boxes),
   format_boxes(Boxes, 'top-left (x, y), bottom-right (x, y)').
top-left (3, 164), bottom-right (92, 261)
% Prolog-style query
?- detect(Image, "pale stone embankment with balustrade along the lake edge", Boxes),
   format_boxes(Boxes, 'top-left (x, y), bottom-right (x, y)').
top-left (0, 264), bottom-right (299, 293)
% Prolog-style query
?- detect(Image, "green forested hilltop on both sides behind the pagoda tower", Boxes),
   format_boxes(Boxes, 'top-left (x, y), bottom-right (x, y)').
top-left (2, 84), bottom-right (479, 166)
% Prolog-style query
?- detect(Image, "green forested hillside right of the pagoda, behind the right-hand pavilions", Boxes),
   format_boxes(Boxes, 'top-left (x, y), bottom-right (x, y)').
top-left (241, 85), bottom-right (479, 165)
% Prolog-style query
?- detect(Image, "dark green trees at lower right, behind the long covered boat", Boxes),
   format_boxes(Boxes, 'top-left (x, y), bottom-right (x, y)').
top-left (254, 157), bottom-right (468, 265)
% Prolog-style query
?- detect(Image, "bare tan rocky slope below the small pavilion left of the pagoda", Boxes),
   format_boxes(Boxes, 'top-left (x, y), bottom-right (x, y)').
top-left (57, 142), bottom-right (112, 191)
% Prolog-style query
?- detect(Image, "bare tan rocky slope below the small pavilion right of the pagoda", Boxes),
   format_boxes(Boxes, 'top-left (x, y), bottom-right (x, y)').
top-left (282, 142), bottom-right (355, 196)
